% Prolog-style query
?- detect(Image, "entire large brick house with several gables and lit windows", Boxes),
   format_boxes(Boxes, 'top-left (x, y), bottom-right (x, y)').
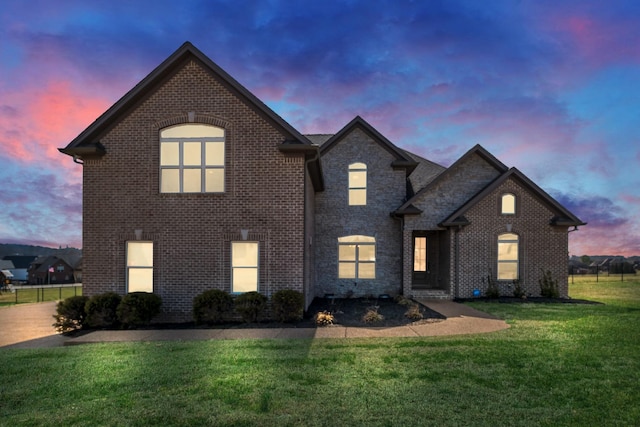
top-left (60, 43), bottom-right (584, 320)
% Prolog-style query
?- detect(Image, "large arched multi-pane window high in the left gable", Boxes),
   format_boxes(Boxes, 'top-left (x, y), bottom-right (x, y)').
top-left (160, 123), bottom-right (225, 193)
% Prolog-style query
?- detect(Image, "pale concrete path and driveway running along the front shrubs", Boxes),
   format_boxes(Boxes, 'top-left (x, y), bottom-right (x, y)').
top-left (0, 300), bottom-right (509, 348)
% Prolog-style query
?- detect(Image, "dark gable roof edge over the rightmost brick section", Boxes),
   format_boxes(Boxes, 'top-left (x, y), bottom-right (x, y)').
top-left (439, 168), bottom-right (587, 227)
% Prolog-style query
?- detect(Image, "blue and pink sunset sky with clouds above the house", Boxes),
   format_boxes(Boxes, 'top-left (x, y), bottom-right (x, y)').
top-left (0, 0), bottom-right (640, 256)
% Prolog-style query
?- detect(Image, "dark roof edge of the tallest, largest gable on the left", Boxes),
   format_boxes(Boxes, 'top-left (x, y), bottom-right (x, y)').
top-left (58, 42), bottom-right (323, 189)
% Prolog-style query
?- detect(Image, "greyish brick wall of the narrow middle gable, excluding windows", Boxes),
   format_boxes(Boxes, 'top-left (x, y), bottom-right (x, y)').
top-left (315, 128), bottom-right (406, 297)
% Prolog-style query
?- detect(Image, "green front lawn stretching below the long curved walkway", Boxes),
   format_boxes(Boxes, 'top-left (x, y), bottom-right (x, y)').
top-left (0, 278), bottom-right (640, 426)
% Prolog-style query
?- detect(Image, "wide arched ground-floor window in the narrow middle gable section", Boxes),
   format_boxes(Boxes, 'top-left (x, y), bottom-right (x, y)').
top-left (338, 236), bottom-right (376, 279)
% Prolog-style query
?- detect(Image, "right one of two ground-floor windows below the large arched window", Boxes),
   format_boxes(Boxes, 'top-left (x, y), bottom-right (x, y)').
top-left (231, 242), bottom-right (260, 293)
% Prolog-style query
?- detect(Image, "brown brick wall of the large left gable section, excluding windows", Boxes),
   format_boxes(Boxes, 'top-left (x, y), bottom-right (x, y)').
top-left (83, 61), bottom-right (310, 320)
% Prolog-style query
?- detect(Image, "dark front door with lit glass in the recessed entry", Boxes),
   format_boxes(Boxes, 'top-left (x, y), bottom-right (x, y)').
top-left (412, 232), bottom-right (440, 289)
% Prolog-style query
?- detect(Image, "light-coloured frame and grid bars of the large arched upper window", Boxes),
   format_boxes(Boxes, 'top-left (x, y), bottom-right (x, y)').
top-left (158, 123), bottom-right (227, 194)
